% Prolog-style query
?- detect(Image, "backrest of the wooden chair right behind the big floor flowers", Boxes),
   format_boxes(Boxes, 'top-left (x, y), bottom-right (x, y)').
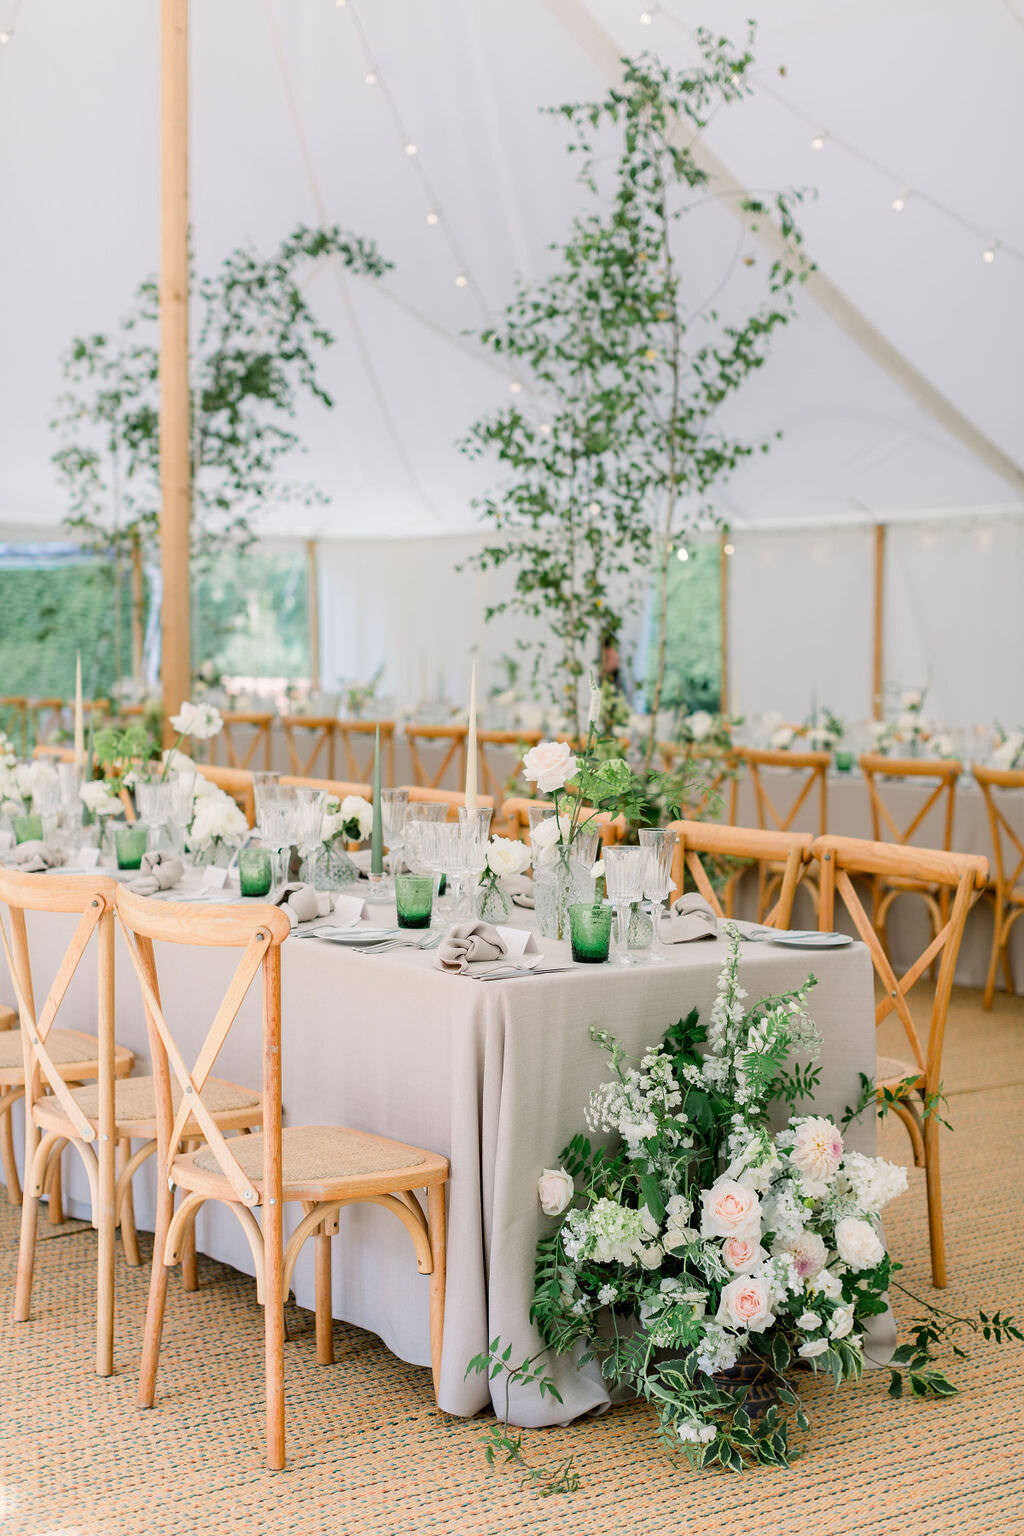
top-left (812, 837), bottom-right (989, 1092)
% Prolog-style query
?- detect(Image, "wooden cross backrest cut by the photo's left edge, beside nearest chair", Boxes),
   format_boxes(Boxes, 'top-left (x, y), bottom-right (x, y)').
top-left (0, 869), bottom-right (117, 1141)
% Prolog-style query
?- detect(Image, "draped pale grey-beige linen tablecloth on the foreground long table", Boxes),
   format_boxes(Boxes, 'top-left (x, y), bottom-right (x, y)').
top-left (0, 914), bottom-right (875, 1425)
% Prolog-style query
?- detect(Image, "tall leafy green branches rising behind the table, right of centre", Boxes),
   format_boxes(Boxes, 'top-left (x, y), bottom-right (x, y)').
top-left (464, 29), bottom-right (806, 749)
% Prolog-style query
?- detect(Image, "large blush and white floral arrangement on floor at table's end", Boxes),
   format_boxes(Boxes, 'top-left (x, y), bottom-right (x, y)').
top-left (531, 932), bottom-right (953, 1470)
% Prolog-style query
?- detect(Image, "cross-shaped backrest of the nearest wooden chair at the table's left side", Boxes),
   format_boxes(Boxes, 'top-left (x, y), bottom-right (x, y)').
top-left (117, 886), bottom-right (290, 1212)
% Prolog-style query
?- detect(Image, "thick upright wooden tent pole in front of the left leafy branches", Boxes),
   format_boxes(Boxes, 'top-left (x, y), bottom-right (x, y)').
top-left (160, 0), bottom-right (192, 740)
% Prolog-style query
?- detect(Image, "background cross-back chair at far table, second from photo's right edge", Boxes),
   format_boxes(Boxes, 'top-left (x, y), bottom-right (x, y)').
top-left (860, 753), bottom-right (964, 946)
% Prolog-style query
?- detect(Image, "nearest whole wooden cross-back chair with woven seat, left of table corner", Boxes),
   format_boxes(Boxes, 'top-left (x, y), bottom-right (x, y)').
top-left (117, 886), bottom-right (448, 1468)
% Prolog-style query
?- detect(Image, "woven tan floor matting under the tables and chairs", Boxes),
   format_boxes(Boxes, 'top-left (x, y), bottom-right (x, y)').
top-left (0, 992), bottom-right (1024, 1536)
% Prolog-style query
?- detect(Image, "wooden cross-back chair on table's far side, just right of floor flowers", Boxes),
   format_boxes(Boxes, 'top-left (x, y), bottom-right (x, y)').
top-left (812, 837), bottom-right (989, 1287)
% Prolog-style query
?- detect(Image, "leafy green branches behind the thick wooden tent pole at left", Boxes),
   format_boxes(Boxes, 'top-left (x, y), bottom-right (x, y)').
top-left (52, 224), bottom-right (388, 678)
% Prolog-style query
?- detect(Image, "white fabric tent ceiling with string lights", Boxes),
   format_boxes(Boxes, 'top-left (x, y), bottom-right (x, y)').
top-left (0, 0), bottom-right (1024, 538)
